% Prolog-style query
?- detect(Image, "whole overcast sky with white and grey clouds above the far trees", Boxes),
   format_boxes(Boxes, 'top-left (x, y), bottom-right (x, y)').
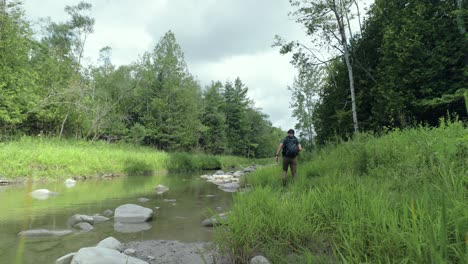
top-left (24, 0), bottom-right (305, 130)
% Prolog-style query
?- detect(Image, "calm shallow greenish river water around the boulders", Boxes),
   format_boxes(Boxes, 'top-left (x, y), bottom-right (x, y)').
top-left (0, 173), bottom-right (232, 264)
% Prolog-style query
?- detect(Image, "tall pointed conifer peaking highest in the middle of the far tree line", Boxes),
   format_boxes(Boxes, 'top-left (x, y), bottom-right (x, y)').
top-left (136, 31), bottom-right (202, 150)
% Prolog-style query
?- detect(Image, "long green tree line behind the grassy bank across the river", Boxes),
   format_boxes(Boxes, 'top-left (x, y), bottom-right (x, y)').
top-left (0, 1), bottom-right (282, 157)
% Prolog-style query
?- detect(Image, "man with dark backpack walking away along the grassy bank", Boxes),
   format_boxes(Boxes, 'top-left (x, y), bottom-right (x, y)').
top-left (276, 129), bottom-right (302, 186)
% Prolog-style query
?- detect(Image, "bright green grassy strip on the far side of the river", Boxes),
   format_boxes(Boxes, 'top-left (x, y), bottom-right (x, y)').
top-left (0, 137), bottom-right (262, 178)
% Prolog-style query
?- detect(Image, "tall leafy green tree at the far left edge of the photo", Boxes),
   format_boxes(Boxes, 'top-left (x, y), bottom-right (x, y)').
top-left (0, 1), bottom-right (39, 133)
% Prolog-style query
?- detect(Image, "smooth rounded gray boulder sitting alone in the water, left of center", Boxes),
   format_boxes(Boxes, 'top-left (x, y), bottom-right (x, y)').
top-left (114, 204), bottom-right (153, 224)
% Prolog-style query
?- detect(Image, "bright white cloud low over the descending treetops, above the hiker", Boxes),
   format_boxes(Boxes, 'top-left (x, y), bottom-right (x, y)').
top-left (189, 49), bottom-right (295, 129)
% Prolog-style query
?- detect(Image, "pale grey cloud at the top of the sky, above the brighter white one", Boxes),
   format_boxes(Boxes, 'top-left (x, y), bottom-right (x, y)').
top-left (144, 0), bottom-right (302, 62)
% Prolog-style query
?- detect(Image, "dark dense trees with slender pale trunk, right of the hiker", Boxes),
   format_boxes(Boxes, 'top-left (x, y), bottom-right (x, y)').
top-left (277, 0), bottom-right (468, 143)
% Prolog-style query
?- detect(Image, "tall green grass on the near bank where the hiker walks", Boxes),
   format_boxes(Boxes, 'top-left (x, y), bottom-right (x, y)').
top-left (215, 120), bottom-right (468, 263)
